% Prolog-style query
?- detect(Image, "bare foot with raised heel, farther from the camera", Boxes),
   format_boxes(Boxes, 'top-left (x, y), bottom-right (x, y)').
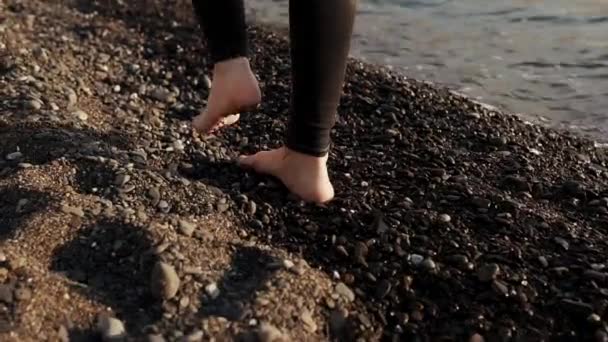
top-left (192, 57), bottom-right (262, 134)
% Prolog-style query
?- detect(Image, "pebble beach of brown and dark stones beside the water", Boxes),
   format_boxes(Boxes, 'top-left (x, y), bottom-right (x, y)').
top-left (0, 0), bottom-right (608, 341)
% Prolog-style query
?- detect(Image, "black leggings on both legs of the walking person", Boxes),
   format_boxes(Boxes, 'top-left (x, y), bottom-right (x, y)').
top-left (192, 0), bottom-right (356, 156)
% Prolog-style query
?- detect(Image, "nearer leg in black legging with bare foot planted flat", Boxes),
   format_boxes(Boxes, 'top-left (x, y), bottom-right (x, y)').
top-left (242, 0), bottom-right (356, 202)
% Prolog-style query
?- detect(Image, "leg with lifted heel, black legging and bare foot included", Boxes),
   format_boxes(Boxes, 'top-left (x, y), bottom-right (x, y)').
top-left (192, 0), bottom-right (261, 133)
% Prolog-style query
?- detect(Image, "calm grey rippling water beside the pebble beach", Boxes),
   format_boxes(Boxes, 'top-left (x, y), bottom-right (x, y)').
top-left (248, 0), bottom-right (608, 141)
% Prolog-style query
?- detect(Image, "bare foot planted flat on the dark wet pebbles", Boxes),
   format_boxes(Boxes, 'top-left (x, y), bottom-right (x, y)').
top-left (239, 147), bottom-right (334, 203)
